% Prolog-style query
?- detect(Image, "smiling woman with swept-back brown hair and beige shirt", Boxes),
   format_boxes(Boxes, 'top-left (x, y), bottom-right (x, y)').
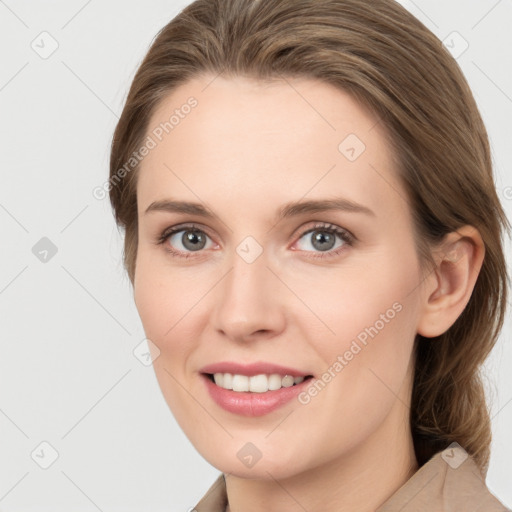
top-left (110, 0), bottom-right (509, 512)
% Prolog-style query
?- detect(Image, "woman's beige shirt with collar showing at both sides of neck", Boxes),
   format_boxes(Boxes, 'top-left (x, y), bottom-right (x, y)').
top-left (192, 448), bottom-right (511, 512)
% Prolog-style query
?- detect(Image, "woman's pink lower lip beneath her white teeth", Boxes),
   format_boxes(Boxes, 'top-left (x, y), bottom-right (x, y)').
top-left (201, 374), bottom-right (313, 416)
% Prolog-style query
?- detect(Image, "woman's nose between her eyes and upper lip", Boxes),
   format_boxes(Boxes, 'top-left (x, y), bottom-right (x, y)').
top-left (211, 245), bottom-right (286, 342)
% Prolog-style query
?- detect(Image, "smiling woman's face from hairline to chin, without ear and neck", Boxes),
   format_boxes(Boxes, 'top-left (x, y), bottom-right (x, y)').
top-left (134, 76), bottom-right (422, 479)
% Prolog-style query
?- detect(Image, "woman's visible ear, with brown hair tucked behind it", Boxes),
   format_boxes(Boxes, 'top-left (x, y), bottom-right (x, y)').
top-left (417, 226), bottom-right (485, 338)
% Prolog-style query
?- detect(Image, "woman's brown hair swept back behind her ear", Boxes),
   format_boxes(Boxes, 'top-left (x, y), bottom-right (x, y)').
top-left (109, 0), bottom-right (510, 475)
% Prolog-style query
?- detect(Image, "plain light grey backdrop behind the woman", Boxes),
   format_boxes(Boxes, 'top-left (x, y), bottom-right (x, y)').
top-left (0, 0), bottom-right (512, 512)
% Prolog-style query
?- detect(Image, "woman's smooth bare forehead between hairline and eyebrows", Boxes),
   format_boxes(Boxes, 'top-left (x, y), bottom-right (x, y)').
top-left (137, 76), bottom-right (405, 222)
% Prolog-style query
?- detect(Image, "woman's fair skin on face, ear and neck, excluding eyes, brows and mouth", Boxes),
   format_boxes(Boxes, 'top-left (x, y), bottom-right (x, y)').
top-left (134, 76), bottom-right (484, 512)
